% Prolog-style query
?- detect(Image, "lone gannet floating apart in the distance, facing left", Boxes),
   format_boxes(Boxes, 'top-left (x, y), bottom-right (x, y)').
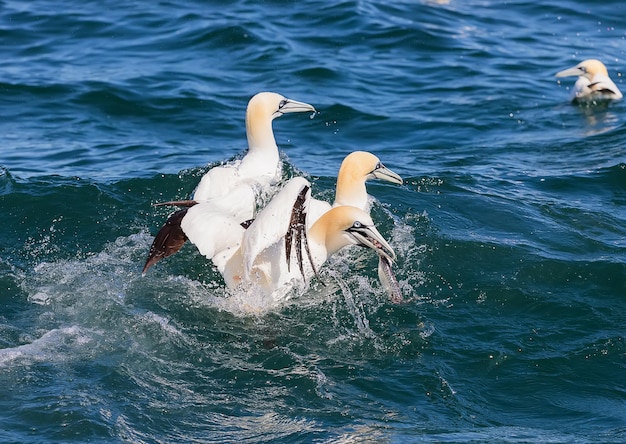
top-left (556, 59), bottom-right (622, 103)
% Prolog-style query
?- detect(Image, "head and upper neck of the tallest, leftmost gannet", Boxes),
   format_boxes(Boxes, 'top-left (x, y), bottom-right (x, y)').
top-left (246, 92), bottom-right (315, 149)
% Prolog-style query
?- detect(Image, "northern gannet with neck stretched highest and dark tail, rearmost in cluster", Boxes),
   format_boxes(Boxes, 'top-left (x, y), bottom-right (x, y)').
top-left (142, 92), bottom-right (315, 274)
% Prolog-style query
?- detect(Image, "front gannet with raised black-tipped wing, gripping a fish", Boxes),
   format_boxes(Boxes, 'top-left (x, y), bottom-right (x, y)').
top-left (210, 177), bottom-right (395, 299)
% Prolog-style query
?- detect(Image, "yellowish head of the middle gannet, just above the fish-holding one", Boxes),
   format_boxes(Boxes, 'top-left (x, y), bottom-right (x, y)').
top-left (334, 151), bottom-right (402, 210)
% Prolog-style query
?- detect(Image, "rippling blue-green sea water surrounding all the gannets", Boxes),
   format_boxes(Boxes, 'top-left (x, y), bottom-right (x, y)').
top-left (0, 0), bottom-right (626, 443)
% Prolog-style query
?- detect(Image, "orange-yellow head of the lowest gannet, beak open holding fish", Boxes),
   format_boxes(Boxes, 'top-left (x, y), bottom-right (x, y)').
top-left (311, 206), bottom-right (396, 262)
